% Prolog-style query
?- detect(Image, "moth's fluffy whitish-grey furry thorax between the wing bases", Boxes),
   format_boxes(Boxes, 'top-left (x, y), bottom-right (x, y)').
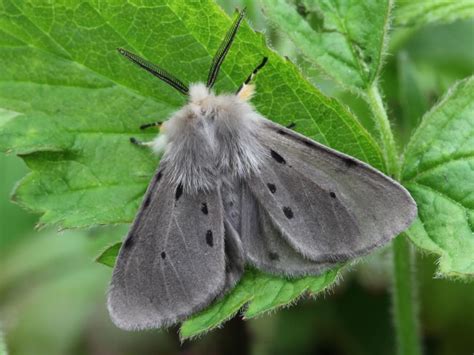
top-left (153, 83), bottom-right (261, 192)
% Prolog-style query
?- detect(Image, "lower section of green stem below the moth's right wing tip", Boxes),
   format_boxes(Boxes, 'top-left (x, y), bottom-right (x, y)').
top-left (392, 233), bottom-right (421, 355)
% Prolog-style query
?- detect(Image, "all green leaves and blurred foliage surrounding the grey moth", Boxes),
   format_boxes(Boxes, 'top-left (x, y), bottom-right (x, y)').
top-left (0, 0), bottom-right (474, 354)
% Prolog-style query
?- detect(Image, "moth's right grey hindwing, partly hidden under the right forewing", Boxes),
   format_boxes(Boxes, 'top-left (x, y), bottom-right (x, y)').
top-left (240, 184), bottom-right (337, 277)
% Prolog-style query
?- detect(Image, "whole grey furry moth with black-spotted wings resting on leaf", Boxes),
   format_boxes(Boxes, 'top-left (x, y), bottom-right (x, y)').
top-left (107, 12), bottom-right (416, 330)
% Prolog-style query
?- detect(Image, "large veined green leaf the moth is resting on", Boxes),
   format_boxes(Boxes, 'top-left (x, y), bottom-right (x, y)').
top-left (0, 0), bottom-right (384, 340)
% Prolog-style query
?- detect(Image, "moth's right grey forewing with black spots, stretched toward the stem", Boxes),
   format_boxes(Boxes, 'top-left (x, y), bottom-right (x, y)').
top-left (248, 119), bottom-right (416, 262)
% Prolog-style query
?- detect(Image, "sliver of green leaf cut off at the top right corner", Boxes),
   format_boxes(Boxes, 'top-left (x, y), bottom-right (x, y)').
top-left (394, 0), bottom-right (474, 26)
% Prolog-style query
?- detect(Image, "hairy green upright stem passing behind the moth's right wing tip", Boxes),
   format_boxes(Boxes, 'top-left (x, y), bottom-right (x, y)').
top-left (367, 83), bottom-right (421, 355)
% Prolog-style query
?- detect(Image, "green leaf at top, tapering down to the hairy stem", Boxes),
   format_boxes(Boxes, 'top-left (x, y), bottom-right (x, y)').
top-left (262, 0), bottom-right (391, 94)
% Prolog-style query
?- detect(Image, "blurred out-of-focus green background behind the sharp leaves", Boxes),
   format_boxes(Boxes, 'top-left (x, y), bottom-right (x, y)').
top-left (0, 0), bottom-right (474, 355)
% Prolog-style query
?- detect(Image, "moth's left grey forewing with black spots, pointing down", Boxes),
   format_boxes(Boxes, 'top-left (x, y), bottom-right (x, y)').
top-left (108, 170), bottom-right (226, 329)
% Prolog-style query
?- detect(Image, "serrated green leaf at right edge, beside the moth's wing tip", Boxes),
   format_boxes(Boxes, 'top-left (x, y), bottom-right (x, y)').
top-left (403, 77), bottom-right (474, 277)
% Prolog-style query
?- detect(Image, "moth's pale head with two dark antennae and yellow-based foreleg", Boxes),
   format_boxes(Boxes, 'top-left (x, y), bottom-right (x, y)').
top-left (118, 9), bottom-right (266, 103)
